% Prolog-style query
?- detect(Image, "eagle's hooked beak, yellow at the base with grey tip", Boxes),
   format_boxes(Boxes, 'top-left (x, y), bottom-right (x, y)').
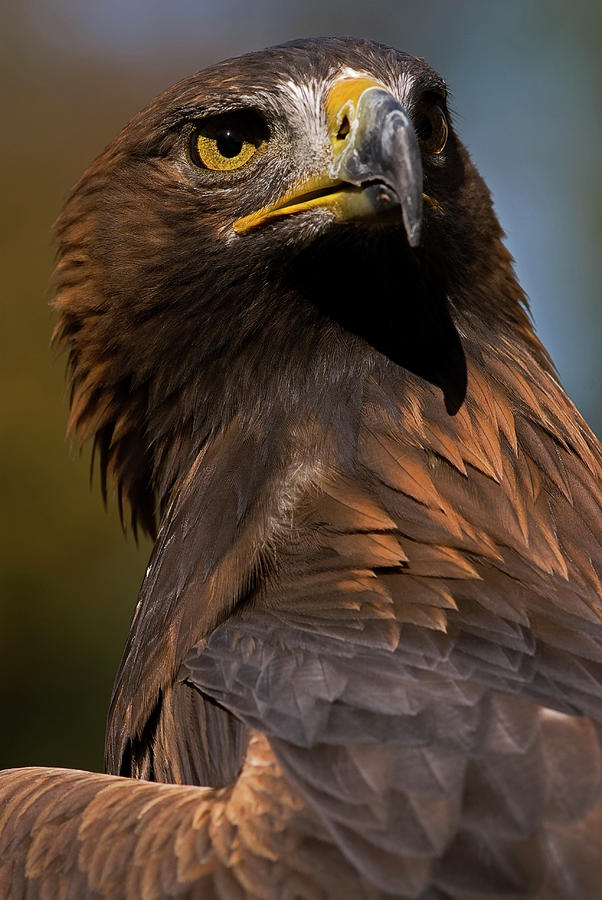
top-left (234, 77), bottom-right (422, 247)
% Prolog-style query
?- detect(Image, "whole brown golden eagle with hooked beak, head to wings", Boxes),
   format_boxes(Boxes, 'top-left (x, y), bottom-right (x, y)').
top-left (0, 39), bottom-right (602, 900)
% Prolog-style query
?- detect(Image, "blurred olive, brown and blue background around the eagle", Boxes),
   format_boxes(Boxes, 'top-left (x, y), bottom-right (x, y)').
top-left (0, 0), bottom-right (602, 770)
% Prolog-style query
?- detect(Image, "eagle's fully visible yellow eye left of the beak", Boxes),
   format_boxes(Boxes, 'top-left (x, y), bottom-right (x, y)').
top-left (189, 110), bottom-right (267, 172)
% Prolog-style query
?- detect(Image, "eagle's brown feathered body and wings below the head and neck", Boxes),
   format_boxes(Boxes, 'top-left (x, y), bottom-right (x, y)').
top-left (9, 334), bottom-right (602, 900)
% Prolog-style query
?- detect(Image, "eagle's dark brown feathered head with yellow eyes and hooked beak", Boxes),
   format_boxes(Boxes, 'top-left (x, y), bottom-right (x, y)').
top-left (54, 39), bottom-right (540, 533)
